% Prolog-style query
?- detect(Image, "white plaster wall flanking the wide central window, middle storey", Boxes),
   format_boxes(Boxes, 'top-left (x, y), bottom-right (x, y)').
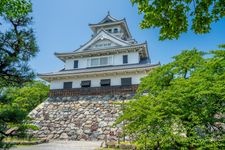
top-left (65, 52), bottom-right (139, 70)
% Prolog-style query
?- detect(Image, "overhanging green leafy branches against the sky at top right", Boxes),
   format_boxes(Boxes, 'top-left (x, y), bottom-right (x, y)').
top-left (131, 0), bottom-right (225, 40)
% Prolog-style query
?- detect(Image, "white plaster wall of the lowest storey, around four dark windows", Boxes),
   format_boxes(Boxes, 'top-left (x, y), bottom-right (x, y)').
top-left (50, 73), bottom-right (146, 89)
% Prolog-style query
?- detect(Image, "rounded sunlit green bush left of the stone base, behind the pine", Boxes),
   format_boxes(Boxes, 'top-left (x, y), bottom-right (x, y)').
top-left (0, 81), bottom-right (49, 117)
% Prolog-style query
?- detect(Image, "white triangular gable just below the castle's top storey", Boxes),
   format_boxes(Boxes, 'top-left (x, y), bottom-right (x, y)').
top-left (75, 30), bottom-right (131, 52)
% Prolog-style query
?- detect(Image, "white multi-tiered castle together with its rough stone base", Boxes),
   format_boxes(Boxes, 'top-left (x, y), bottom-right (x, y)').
top-left (30, 13), bottom-right (159, 140)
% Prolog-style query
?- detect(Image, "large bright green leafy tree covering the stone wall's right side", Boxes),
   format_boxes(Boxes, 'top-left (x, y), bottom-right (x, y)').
top-left (117, 46), bottom-right (225, 149)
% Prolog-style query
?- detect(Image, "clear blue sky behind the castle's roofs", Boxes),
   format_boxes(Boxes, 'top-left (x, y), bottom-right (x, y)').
top-left (30, 0), bottom-right (225, 73)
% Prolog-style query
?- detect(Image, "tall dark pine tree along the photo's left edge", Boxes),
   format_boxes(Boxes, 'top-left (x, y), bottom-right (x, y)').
top-left (0, 0), bottom-right (39, 148)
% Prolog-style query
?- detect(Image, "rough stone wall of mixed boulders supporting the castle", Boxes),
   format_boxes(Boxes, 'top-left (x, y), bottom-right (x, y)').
top-left (30, 94), bottom-right (133, 141)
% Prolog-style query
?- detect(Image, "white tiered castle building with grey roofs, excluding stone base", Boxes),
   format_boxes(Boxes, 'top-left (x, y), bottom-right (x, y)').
top-left (38, 13), bottom-right (159, 96)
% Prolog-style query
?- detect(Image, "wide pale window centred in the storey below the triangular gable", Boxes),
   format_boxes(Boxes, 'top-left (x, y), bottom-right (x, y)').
top-left (87, 56), bottom-right (112, 67)
